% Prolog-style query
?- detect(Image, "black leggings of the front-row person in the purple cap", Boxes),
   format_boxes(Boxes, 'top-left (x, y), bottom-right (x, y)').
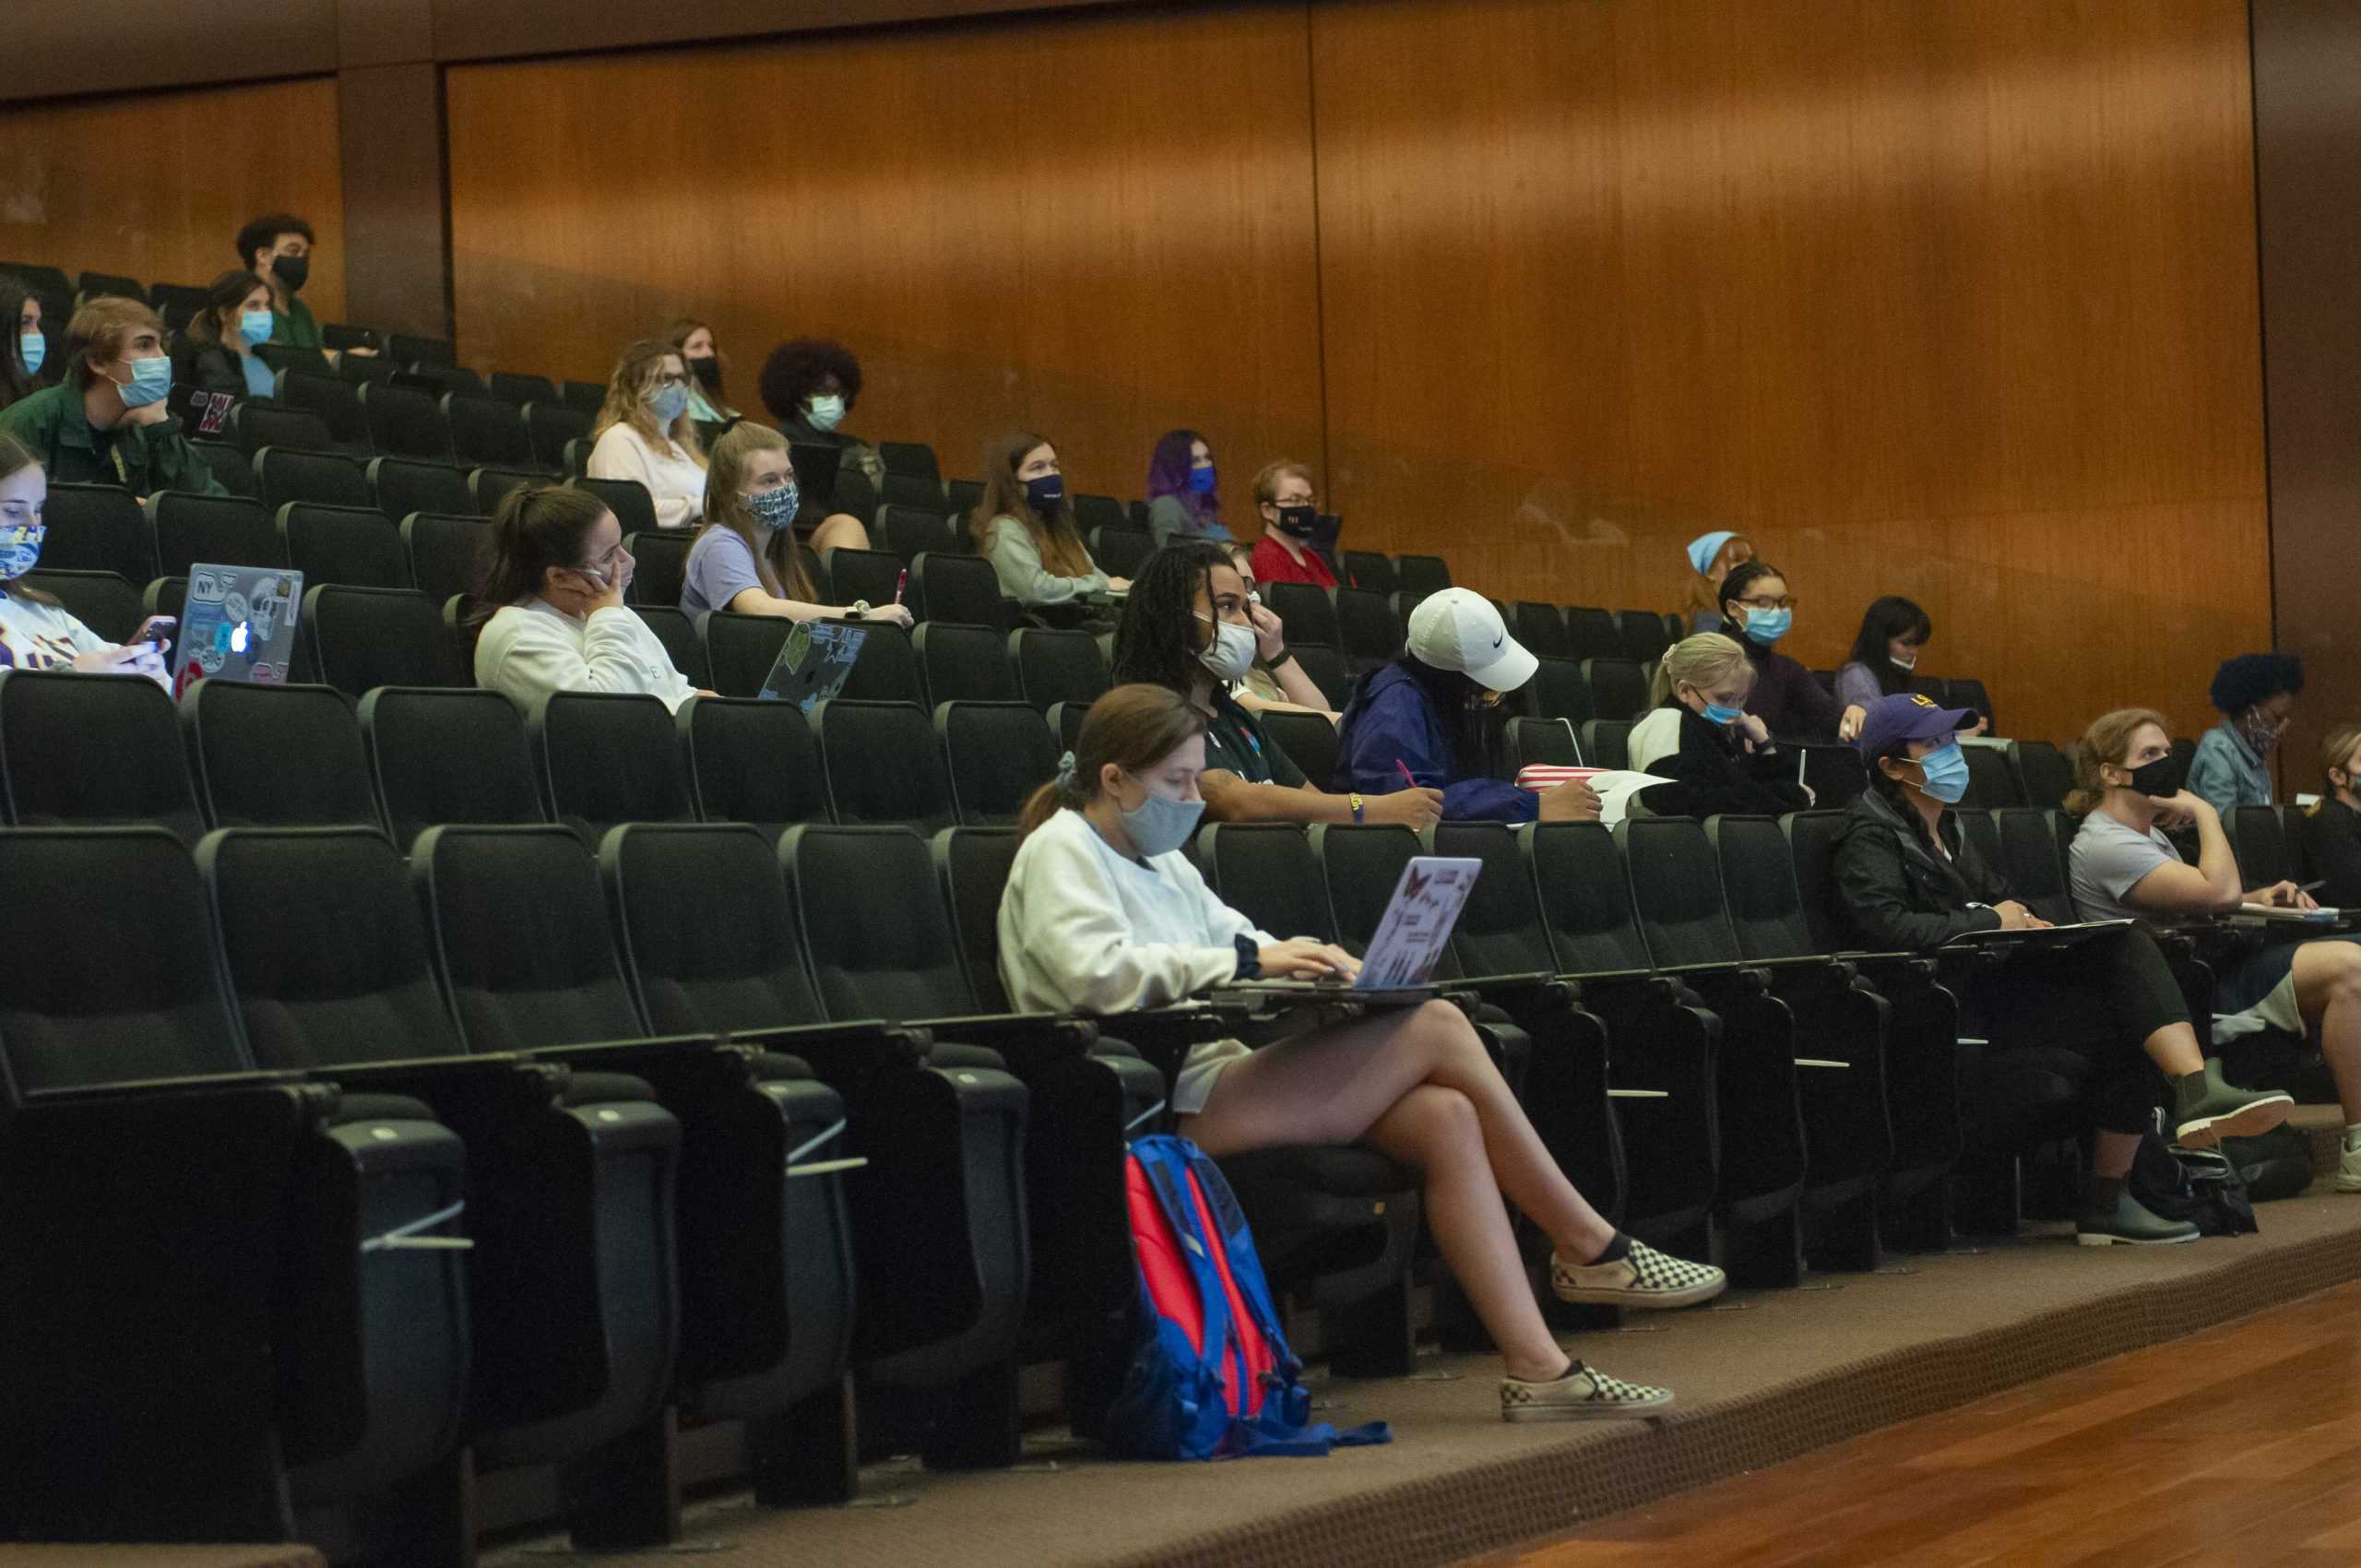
top-left (1964, 926), bottom-right (2189, 1134)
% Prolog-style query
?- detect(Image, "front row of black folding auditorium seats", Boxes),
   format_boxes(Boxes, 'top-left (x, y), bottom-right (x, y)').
top-left (0, 760), bottom-right (2162, 1561)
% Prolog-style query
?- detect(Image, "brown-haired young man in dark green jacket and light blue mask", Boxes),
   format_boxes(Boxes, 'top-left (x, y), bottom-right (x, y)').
top-left (0, 295), bottom-right (229, 496)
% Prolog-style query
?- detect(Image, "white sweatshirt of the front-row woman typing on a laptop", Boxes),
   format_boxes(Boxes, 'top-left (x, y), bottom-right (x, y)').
top-left (999, 810), bottom-right (1275, 1114)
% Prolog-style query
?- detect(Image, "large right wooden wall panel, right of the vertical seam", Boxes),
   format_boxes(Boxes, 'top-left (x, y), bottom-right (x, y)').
top-left (1311, 0), bottom-right (2269, 734)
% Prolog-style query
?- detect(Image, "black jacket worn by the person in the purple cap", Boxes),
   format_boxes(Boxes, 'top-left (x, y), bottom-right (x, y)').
top-left (1834, 784), bottom-right (2010, 952)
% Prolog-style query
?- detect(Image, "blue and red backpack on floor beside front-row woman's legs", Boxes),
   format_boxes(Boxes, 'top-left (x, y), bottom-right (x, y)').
top-left (1108, 1135), bottom-right (1393, 1459)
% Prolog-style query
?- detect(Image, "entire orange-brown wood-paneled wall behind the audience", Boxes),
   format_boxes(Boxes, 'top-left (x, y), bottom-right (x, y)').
top-left (0, 0), bottom-right (2272, 737)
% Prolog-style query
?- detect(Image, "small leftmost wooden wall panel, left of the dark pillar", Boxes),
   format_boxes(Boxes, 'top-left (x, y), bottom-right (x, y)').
top-left (0, 77), bottom-right (345, 321)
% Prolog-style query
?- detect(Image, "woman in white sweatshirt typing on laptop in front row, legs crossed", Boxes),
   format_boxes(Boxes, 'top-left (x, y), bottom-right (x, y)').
top-left (999, 684), bottom-right (1726, 1421)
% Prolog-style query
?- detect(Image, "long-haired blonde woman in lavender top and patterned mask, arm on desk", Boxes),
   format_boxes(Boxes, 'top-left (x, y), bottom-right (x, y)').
top-left (680, 425), bottom-right (911, 625)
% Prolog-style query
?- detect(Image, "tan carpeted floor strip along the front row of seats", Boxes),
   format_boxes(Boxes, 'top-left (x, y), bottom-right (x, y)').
top-left (484, 1138), bottom-right (2361, 1568)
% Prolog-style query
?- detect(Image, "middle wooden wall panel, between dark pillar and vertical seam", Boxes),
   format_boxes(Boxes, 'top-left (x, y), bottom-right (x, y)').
top-left (446, 9), bottom-right (1320, 515)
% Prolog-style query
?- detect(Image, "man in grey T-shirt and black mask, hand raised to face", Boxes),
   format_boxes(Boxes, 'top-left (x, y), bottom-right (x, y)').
top-left (2066, 708), bottom-right (2361, 1193)
